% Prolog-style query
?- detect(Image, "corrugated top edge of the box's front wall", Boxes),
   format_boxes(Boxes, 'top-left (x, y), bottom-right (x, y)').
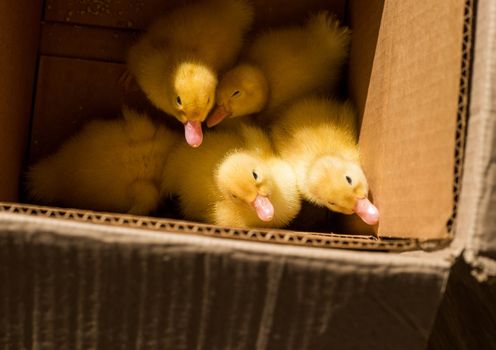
top-left (0, 203), bottom-right (420, 252)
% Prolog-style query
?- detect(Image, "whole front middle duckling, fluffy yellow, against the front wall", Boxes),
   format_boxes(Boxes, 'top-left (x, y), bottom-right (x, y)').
top-left (162, 125), bottom-right (300, 227)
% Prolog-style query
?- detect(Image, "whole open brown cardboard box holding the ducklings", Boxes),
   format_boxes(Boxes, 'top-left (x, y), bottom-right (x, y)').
top-left (0, 0), bottom-right (496, 349)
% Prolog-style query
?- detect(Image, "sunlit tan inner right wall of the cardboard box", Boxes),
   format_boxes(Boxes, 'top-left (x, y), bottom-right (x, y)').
top-left (360, 0), bottom-right (464, 239)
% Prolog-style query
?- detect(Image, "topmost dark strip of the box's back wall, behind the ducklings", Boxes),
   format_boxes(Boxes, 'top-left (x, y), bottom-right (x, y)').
top-left (45, 0), bottom-right (345, 29)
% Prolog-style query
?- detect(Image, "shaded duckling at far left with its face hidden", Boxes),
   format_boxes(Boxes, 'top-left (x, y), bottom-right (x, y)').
top-left (27, 108), bottom-right (180, 215)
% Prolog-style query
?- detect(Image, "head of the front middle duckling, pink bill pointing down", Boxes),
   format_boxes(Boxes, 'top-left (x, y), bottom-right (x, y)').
top-left (216, 153), bottom-right (274, 222)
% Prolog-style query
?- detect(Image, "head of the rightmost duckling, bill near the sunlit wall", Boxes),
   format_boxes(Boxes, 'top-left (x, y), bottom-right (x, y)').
top-left (307, 156), bottom-right (379, 225)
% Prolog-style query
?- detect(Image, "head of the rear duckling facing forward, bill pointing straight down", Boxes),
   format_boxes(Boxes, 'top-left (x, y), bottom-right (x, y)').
top-left (170, 62), bottom-right (217, 147)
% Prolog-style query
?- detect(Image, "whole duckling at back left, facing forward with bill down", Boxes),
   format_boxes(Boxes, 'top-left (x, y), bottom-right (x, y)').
top-left (128, 0), bottom-right (253, 147)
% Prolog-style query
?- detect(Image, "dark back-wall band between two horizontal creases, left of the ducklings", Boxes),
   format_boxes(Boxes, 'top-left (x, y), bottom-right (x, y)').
top-left (40, 22), bottom-right (136, 62)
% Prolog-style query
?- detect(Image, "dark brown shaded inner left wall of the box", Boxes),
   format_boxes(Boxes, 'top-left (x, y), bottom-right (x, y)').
top-left (0, 0), bottom-right (41, 200)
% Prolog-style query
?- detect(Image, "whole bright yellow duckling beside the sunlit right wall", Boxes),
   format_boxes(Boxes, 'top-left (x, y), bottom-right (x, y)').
top-left (271, 97), bottom-right (379, 225)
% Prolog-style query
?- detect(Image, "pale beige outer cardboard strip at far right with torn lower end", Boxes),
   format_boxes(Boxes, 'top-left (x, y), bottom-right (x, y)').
top-left (454, 0), bottom-right (496, 280)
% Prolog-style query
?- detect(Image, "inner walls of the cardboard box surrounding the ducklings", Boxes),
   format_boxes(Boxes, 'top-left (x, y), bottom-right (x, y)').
top-left (0, 0), bottom-right (469, 247)
